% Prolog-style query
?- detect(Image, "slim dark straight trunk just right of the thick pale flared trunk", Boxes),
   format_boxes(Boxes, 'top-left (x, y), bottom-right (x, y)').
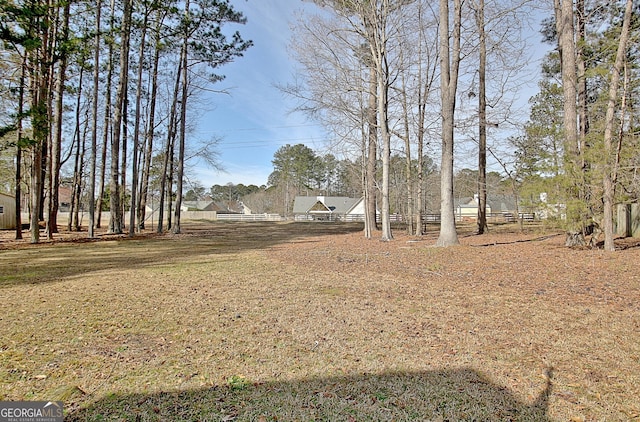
top-left (476, 0), bottom-right (487, 234)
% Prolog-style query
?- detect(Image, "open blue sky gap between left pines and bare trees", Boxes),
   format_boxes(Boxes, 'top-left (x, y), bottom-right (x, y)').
top-left (193, 0), bottom-right (324, 189)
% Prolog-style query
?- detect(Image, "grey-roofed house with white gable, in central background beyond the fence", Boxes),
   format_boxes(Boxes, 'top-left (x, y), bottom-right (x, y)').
top-left (293, 196), bottom-right (364, 221)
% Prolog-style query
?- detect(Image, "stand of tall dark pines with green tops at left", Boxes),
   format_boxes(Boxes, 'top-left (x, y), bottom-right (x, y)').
top-left (0, 0), bottom-right (252, 242)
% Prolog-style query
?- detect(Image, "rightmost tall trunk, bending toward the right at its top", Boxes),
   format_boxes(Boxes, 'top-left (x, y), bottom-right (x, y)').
top-left (602, 0), bottom-right (633, 251)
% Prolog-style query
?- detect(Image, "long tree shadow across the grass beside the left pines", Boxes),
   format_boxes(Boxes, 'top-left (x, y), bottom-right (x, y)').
top-left (0, 221), bottom-right (362, 288)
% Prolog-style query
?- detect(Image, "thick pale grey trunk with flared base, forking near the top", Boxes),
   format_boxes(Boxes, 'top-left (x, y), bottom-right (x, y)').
top-left (436, 0), bottom-right (462, 246)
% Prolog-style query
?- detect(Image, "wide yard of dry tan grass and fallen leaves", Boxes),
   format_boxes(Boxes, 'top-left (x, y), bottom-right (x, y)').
top-left (0, 222), bottom-right (640, 421)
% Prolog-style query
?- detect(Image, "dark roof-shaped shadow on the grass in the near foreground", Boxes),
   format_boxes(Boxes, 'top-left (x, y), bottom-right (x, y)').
top-left (65, 369), bottom-right (551, 422)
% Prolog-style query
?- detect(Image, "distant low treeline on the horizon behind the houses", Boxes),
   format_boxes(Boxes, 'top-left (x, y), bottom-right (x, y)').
top-left (198, 144), bottom-right (512, 217)
